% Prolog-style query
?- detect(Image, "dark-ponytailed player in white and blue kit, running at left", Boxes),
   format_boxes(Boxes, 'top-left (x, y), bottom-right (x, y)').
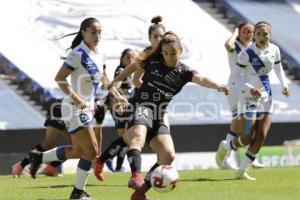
top-left (30, 18), bottom-right (126, 199)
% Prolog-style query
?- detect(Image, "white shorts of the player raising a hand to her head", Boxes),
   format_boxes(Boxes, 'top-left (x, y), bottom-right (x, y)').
top-left (226, 84), bottom-right (240, 118)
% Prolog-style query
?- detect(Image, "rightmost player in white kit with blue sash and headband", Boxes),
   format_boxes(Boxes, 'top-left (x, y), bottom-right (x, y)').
top-left (220, 21), bottom-right (290, 180)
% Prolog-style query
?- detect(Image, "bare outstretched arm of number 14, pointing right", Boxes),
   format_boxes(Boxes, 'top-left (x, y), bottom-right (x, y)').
top-left (192, 73), bottom-right (229, 95)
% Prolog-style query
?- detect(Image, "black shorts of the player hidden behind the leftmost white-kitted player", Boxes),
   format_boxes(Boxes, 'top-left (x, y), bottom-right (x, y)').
top-left (44, 100), bottom-right (66, 130)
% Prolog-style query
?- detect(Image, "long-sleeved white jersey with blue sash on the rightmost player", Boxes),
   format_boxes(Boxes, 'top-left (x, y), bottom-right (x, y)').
top-left (237, 43), bottom-right (287, 100)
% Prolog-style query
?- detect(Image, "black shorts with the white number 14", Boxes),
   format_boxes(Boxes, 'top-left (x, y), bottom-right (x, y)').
top-left (128, 106), bottom-right (170, 145)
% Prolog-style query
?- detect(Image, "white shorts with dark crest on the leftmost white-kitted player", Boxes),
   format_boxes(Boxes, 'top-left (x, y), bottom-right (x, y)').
top-left (61, 102), bottom-right (94, 134)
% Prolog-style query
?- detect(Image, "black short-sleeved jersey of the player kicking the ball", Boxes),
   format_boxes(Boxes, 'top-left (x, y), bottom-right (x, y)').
top-left (130, 55), bottom-right (196, 109)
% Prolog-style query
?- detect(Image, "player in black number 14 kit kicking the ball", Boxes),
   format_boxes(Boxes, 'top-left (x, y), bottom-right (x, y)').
top-left (95, 32), bottom-right (229, 200)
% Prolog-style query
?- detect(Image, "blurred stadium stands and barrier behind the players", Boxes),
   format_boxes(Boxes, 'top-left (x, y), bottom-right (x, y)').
top-left (0, 0), bottom-right (300, 174)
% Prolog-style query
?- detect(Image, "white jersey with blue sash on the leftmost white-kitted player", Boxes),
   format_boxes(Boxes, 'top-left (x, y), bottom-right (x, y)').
top-left (63, 41), bottom-right (105, 105)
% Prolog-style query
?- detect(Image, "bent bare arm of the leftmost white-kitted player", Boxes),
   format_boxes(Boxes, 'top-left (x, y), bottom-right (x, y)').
top-left (55, 66), bottom-right (86, 109)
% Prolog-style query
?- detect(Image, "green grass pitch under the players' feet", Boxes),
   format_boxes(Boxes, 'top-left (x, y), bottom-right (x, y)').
top-left (0, 167), bottom-right (300, 200)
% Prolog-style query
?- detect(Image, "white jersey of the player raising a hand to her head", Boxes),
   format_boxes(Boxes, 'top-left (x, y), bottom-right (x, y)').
top-left (228, 40), bottom-right (251, 87)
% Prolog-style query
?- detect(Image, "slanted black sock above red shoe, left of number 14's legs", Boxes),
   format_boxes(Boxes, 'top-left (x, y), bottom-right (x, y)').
top-left (100, 137), bottom-right (127, 163)
